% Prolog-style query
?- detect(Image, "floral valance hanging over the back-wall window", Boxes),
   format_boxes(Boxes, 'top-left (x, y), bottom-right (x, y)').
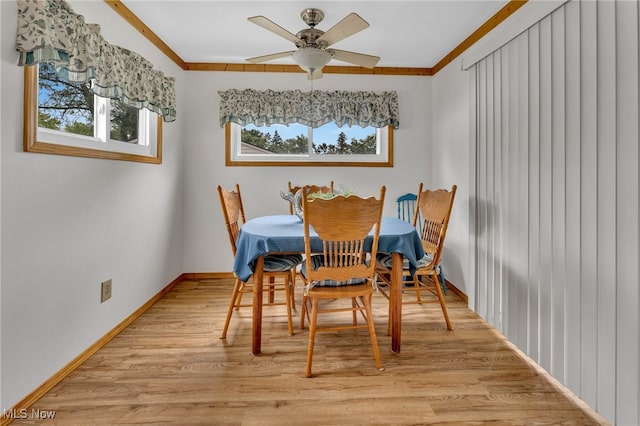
top-left (218, 89), bottom-right (400, 128)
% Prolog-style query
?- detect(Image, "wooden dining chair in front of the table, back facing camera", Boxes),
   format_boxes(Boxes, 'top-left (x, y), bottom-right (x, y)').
top-left (300, 186), bottom-right (385, 377)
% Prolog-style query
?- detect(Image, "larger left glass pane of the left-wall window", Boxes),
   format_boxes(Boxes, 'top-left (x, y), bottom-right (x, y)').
top-left (38, 63), bottom-right (94, 136)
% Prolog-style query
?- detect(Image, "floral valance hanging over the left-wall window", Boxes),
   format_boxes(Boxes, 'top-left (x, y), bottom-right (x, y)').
top-left (16, 0), bottom-right (176, 121)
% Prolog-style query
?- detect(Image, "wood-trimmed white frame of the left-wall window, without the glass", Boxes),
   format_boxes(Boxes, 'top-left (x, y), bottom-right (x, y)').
top-left (24, 65), bottom-right (162, 164)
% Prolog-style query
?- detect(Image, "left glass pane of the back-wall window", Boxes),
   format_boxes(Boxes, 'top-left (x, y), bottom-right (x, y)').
top-left (240, 124), bottom-right (309, 155)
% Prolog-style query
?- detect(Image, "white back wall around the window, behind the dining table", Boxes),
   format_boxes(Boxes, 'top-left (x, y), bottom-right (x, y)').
top-left (184, 72), bottom-right (431, 272)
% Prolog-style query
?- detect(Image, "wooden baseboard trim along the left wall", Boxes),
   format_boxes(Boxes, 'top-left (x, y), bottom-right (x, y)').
top-left (0, 274), bottom-right (188, 426)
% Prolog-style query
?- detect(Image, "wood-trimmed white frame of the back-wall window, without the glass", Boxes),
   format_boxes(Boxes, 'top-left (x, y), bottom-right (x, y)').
top-left (225, 123), bottom-right (393, 167)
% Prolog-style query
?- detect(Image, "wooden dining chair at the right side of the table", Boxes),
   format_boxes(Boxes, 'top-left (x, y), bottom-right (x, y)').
top-left (376, 183), bottom-right (457, 330)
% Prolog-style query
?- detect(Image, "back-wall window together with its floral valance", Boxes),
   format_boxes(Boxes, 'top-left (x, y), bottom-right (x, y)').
top-left (218, 89), bottom-right (400, 167)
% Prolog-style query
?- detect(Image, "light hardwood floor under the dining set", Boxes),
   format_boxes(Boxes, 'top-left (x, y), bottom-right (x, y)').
top-left (12, 279), bottom-right (607, 425)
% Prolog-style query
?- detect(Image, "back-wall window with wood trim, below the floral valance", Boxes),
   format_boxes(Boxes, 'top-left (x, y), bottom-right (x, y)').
top-left (225, 122), bottom-right (393, 167)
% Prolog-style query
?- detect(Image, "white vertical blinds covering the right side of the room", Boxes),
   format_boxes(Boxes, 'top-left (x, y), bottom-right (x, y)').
top-left (470, 0), bottom-right (640, 425)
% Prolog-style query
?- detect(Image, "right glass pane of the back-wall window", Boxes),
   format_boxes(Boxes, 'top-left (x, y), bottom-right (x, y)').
top-left (313, 123), bottom-right (377, 155)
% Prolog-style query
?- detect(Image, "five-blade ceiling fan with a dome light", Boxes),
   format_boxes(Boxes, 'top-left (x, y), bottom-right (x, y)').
top-left (247, 8), bottom-right (380, 80)
